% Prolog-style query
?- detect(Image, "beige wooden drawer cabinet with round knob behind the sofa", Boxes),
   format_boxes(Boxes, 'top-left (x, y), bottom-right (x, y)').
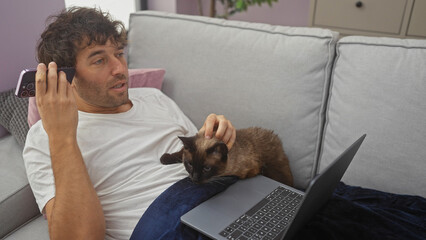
top-left (309, 0), bottom-right (426, 38)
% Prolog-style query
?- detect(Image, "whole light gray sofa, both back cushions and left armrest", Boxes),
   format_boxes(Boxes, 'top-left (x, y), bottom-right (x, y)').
top-left (0, 11), bottom-right (426, 240)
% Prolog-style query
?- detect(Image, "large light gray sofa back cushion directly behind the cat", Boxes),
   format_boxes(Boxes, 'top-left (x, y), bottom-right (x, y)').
top-left (129, 11), bottom-right (338, 188)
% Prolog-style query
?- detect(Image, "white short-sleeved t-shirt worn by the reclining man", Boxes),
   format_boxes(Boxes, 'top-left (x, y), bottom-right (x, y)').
top-left (23, 88), bottom-right (197, 239)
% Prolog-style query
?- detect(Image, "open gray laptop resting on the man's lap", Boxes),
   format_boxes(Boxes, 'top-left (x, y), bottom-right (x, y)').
top-left (181, 134), bottom-right (366, 239)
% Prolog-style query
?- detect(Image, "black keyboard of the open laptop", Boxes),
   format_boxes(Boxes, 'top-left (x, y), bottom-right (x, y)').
top-left (220, 187), bottom-right (303, 240)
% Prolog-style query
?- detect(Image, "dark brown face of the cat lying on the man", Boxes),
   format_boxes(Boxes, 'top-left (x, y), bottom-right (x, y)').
top-left (179, 135), bottom-right (228, 183)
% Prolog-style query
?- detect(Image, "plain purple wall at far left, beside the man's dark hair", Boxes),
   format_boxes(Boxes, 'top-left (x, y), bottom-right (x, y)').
top-left (0, 0), bottom-right (65, 136)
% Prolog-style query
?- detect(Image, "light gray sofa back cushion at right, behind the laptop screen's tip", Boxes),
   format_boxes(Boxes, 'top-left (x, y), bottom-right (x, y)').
top-left (320, 37), bottom-right (426, 197)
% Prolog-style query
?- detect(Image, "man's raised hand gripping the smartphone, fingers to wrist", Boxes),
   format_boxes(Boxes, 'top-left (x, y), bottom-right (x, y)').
top-left (36, 62), bottom-right (78, 140)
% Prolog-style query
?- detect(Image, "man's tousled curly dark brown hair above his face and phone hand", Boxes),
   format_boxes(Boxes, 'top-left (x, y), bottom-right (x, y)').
top-left (37, 7), bottom-right (127, 67)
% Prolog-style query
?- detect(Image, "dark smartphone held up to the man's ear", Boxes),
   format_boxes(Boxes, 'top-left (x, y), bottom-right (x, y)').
top-left (15, 67), bottom-right (75, 98)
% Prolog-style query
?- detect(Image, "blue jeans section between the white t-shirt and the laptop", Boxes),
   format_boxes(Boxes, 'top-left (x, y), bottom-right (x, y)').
top-left (130, 177), bottom-right (237, 240)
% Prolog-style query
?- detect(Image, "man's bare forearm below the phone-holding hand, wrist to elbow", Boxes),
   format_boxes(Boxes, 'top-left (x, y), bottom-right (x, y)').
top-left (45, 136), bottom-right (105, 239)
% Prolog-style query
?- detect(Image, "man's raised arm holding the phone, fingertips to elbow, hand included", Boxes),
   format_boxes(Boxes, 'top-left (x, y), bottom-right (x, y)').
top-left (36, 63), bottom-right (105, 239)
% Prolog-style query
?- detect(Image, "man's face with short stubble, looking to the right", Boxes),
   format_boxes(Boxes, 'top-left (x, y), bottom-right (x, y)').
top-left (73, 41), bottom-right (129, 113)
